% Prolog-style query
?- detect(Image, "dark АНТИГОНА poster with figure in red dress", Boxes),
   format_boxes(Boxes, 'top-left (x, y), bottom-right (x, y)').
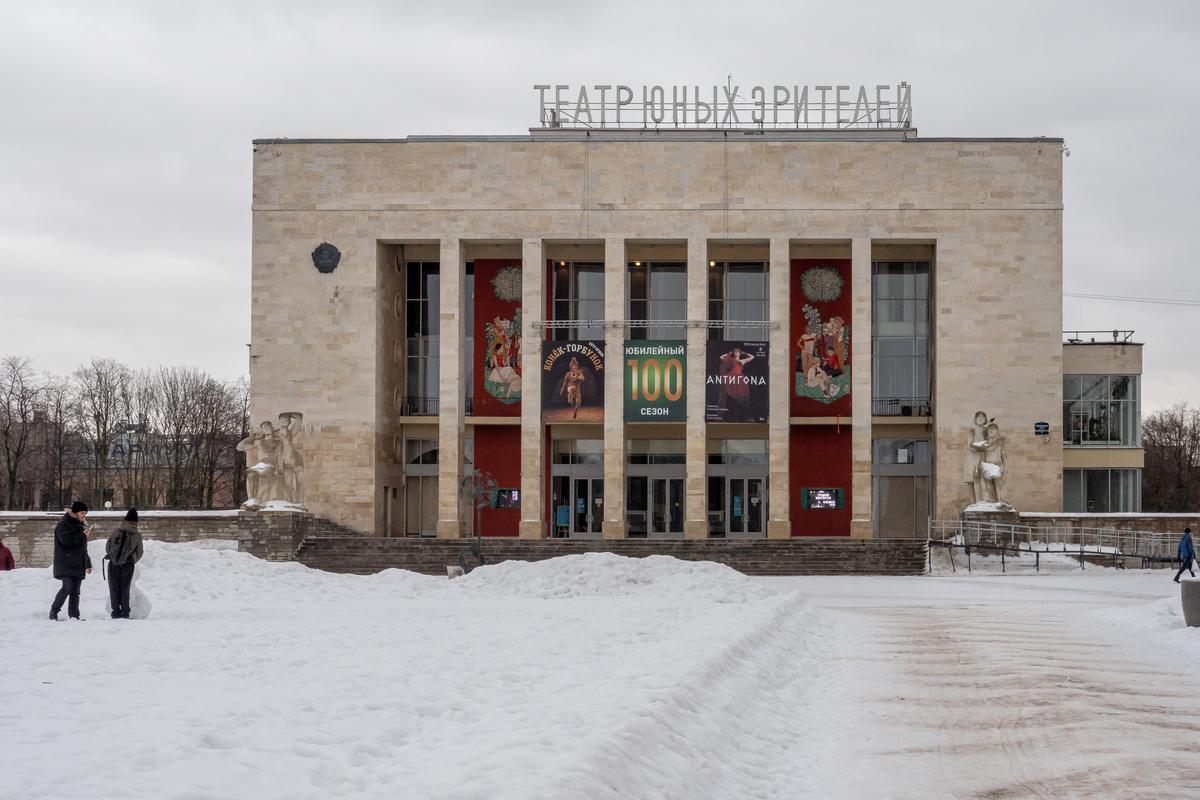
top-left (704, 342), bottom-right (769, 422)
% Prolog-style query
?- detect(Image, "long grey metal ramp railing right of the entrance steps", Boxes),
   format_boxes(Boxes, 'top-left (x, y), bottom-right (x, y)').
top-left (929, 519), bottom-right (1178, 565)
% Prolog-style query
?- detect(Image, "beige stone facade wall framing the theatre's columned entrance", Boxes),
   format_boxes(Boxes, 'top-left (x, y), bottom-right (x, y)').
top-left (251, 134), bottom-right (1063, 530)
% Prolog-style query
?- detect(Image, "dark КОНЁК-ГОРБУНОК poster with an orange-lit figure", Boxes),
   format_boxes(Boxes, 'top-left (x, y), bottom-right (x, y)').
top-left (541, 339), bottom-right (604, 422)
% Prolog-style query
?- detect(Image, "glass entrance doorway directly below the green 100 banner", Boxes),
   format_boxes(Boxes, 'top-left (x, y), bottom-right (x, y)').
top-left (625, 439), bottom-right (684, 539)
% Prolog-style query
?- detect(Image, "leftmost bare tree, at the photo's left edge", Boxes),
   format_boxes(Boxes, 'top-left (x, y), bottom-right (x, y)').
top-left (0, 355), bottom-right (42, 509)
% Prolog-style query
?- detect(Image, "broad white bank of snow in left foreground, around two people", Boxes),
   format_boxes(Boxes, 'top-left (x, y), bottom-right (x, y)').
top-left (7, 541), bottom-right (804, 800)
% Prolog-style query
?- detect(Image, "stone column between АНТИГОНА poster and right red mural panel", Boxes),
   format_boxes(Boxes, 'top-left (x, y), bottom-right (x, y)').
top-left (767, 236), bottom-right (792, 539)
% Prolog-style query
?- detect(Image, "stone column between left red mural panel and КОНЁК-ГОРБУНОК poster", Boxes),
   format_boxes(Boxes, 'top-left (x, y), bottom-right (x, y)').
top-left (518, 239), bottom-right (546, 539)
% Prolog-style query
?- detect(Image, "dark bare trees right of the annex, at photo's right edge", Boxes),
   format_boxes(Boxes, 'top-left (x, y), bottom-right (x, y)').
top-left (1141, 403), bottom-right (1200, 512)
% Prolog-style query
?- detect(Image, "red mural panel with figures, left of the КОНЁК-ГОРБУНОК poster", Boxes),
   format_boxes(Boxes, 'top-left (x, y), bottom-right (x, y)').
top-left (472, 260), bottom-right (522, 416)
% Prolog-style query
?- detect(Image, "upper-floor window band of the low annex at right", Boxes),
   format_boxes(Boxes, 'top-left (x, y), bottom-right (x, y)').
top-left (1062, 375), bottom-right (1141, 447)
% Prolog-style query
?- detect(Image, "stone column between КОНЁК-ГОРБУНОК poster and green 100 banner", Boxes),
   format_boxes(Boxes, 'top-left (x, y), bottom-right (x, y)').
top-left (601, 239), bottom-right (626, 539)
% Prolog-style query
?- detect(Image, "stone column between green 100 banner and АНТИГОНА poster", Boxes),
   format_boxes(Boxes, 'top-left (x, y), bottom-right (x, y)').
top-left (683, 236), bottom-right (708, 539)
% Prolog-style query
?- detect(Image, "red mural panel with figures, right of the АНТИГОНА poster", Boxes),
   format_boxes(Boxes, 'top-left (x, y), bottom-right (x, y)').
top-left (791, 259), bottom-right (854, 416)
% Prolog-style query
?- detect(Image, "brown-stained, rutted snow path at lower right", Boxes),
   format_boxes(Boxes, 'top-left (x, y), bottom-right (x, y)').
top-left (804, 606), bottom-right (1200, 800)
